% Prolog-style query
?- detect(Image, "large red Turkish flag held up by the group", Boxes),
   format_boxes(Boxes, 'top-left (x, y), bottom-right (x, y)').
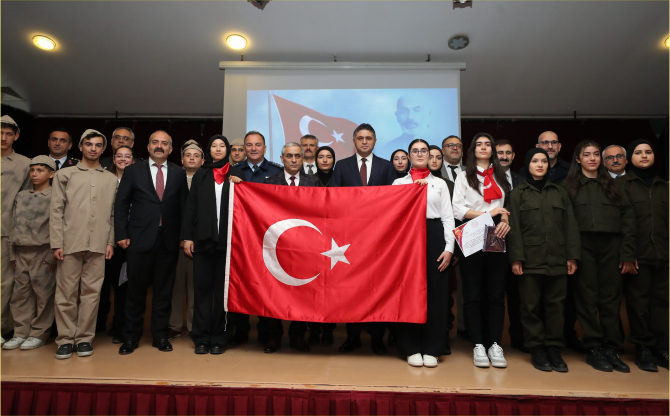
top-left (225, 182), bottom-right (427, 323)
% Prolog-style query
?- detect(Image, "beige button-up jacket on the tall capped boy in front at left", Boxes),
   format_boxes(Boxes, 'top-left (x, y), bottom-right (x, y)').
top-left (49, 163), bottom-right (119, 254)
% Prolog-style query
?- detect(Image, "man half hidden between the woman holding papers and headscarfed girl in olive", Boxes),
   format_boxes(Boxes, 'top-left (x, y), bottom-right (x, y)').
top-left (496, 139), bottom-right (528, 352)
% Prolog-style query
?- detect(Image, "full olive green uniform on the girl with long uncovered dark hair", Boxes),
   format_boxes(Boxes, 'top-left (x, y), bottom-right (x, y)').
top-left (572, 175), bottom-right (635, 351)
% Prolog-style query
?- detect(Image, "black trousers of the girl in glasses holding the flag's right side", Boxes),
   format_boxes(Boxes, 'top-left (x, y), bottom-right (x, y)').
top-left (396, 219), bottom-right (451, 357)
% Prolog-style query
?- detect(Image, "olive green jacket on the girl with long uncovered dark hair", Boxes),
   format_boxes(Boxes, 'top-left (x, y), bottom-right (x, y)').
top-left (572, 175), bottom-right (636, 262)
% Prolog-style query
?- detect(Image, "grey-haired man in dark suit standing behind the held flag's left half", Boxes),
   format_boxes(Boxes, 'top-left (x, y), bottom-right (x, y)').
top-left (260, 142), bottom-right (319, 354)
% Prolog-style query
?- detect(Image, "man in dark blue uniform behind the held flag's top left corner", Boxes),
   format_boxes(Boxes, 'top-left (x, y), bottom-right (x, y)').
top-left (228, 130), bottom-right (284, 347)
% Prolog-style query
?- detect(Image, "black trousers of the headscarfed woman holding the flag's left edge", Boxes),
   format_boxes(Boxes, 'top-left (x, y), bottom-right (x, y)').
top-left (191, 249), bottom-right (228, 345)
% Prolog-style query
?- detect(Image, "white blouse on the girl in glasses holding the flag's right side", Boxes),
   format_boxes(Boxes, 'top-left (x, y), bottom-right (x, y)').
top-left (393, 173), bottom-right (455, 253)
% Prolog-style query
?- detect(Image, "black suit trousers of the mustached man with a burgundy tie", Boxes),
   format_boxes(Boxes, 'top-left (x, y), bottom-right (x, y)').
top-left (123, 229), bottom-right (179, 342)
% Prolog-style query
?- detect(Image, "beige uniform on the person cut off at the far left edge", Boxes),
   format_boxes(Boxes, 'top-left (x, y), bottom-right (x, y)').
top-left (0, 152), bottom-right (32, 332)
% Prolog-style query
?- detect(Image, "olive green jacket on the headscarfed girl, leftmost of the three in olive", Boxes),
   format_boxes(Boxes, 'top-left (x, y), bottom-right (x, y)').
top-left (507, 182), bottom-right (581, 276)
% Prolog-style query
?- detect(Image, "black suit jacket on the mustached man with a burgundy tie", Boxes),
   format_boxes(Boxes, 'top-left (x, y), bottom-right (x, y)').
top-left (114, 159), bottom-right (188, 252)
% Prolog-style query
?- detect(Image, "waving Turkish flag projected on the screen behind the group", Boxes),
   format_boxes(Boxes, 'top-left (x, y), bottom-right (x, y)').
top-left (272, 94), bottom-right (358, 157)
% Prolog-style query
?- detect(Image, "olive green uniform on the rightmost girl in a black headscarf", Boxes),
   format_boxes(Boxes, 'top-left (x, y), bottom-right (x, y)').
top-left (615, 171), bottom-right (669, 351)
